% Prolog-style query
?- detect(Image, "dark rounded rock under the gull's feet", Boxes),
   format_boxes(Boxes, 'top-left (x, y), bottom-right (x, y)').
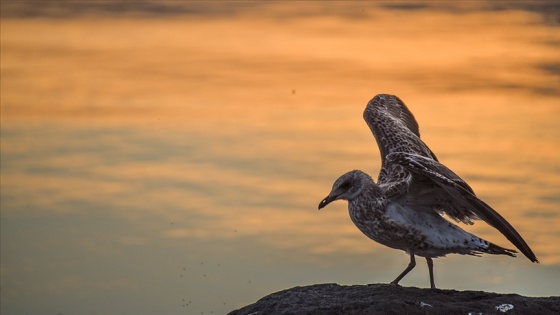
top-left (229, 284), bottom-right (560, 315)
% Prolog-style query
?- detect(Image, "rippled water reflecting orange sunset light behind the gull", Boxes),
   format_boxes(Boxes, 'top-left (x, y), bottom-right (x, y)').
top-left (0, 1), bottom-right (560, 315)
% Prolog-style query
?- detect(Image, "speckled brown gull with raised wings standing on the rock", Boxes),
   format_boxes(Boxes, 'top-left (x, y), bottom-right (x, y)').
top-left (318, 94), bottom-right (538, 289)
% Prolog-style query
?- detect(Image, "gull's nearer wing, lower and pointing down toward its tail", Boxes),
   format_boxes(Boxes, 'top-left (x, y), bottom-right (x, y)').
top-left (386, 152), bottom-right (538, 262)
